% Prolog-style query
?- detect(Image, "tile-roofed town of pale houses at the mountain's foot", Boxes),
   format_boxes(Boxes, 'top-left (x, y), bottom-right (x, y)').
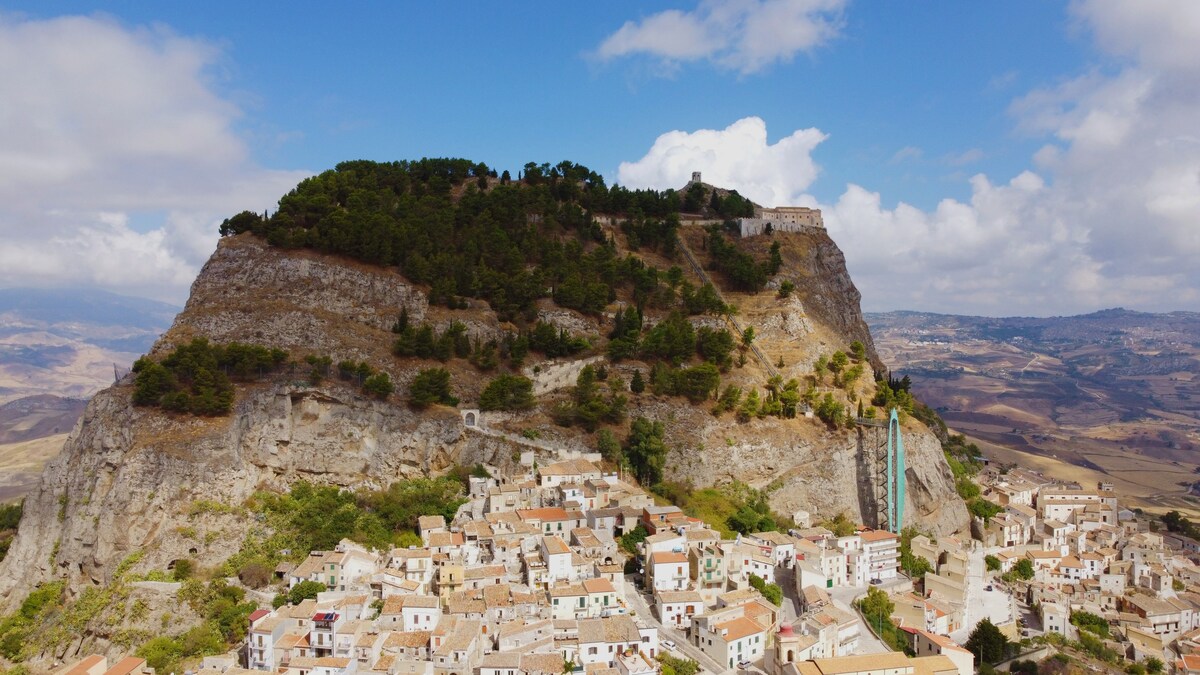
top-left (54, 441), bottom-right (1200, 675)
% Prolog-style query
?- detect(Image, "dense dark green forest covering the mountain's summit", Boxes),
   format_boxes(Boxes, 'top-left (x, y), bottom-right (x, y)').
top-left (221, 159), bottom-right (754, 321)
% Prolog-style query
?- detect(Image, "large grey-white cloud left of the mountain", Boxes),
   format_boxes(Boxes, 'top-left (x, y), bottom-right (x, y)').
top-left (0, 16), bottom-right (306, 301)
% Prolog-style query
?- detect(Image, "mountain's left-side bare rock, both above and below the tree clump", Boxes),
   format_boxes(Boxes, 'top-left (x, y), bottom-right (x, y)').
top-left (0, 237), bottom-right (515, 598)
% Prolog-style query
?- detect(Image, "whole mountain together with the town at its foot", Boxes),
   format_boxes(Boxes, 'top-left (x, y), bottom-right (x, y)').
top-left (21, 160), bottom-right (1200, 675)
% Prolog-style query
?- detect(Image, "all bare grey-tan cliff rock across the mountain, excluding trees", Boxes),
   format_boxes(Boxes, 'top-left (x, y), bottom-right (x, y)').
top-left (0, 229), bottom-right (967, 607)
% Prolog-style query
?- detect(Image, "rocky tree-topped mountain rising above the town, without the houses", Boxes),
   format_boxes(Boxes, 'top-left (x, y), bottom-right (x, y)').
top-left (0, 160), bottom-right (967, 658)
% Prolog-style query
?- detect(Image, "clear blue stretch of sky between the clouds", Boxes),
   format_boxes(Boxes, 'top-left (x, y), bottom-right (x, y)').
top-left (25, 2), bottom-right (1090, 208)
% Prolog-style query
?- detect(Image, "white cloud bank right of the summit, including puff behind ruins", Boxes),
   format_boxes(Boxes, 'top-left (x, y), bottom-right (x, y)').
top-left (620, 0), bottom-right (1200, 315)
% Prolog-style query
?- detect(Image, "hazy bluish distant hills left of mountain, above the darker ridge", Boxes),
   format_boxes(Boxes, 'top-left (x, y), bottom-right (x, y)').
top-left (0, 288), bottom-right (179, 402)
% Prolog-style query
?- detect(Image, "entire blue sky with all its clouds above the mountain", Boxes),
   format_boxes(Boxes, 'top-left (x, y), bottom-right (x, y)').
top-left (0, 0), bottom-right (1200, 315)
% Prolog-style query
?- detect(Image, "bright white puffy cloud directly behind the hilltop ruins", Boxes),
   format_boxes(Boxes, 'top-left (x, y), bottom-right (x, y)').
top-left (617, 118), bottom-right (827, 207)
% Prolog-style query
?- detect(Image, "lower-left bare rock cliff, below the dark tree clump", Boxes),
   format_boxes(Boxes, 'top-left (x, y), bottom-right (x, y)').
top-left (0, 374), bottom-right (514, 593)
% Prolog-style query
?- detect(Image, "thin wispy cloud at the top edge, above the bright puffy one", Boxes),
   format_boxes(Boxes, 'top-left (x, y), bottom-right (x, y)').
top-left (595, 0), bottom-right (846, 74)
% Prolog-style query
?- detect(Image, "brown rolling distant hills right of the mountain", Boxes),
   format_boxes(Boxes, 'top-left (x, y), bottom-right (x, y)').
top-left (865, 309), bottom-right (1200, 508)
